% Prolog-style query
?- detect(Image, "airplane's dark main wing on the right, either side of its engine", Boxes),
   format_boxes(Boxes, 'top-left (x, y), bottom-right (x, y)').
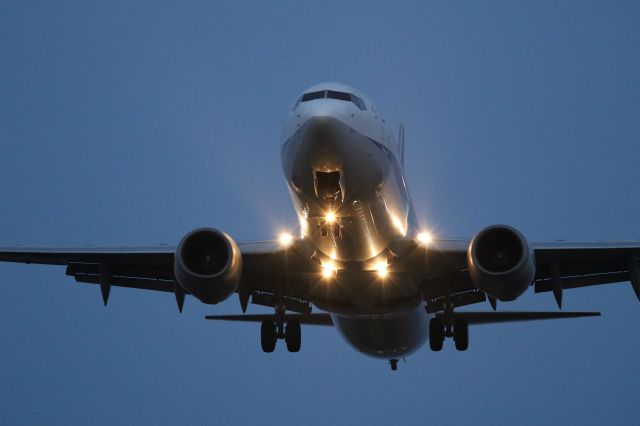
top-left (420, 240), bottom-right (640, 312)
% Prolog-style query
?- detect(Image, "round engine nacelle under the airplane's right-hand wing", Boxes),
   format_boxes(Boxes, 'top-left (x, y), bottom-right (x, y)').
top-left (467, 225), bottom-right (536, 301)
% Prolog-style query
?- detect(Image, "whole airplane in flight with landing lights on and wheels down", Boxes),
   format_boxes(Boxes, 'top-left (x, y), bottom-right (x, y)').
top-left (0, 83), bottom-right (640, 370)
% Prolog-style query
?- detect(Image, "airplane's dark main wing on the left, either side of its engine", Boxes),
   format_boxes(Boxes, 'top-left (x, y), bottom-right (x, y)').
top-left (0, 241), bottom-right (309, 313)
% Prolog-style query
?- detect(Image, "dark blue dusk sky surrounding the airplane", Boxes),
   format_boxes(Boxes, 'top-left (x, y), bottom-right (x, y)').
top-left (0, 1), bottom-right (640, 425)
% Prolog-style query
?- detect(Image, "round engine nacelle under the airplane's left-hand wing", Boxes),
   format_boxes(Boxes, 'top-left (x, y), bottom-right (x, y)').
top-left (174, 228), bottom-right (242, 304)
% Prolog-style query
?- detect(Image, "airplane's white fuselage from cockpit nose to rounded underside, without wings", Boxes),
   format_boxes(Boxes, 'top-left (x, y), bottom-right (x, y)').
top-left (282, 83), bottom-right (428, 358)
